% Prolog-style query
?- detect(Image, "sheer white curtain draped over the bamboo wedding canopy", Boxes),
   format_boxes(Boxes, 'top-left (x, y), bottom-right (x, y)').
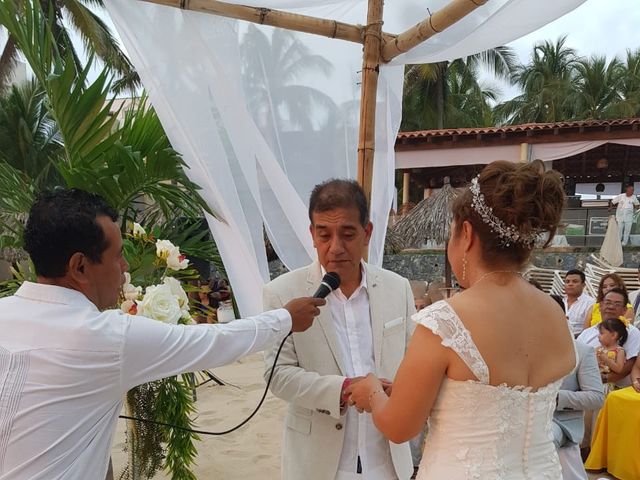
top-left (105, 0), bottom-right (584, 315)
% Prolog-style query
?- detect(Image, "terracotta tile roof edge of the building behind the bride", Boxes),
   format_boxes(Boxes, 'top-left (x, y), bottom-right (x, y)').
top-left (398, 118), bottom-right (640, 140)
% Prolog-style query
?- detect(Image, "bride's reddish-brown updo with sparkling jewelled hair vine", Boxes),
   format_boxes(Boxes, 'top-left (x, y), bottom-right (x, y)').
top-left (452, 160), bottom-right (564, 266)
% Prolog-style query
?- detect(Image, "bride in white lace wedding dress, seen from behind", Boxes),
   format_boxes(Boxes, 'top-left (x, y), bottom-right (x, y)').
top-left (350, 161), bottom-right (576, 480)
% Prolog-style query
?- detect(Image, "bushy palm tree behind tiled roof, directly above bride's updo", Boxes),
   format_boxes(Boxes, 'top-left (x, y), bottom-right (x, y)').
top-left (495, 37), bottom-right (580, 124)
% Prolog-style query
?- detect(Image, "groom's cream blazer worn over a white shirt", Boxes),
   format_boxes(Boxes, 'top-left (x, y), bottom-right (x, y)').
top-left (264, 262), bottom-right (415, 480)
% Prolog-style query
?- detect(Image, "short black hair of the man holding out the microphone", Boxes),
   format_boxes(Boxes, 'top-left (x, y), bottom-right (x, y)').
top-left (24, 188), bottom-right (118, 278)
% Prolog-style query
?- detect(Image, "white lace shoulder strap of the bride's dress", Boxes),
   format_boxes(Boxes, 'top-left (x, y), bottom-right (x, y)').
top-left (412, 300), bottom-right (489, 384)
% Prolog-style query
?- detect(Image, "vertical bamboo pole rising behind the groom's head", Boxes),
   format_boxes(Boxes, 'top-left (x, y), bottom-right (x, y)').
top-left (357, 0), bottom-right (384, 208)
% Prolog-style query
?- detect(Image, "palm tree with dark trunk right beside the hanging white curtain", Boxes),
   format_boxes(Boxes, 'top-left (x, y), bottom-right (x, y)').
top-left (401, 46), bottom-right (516, 130)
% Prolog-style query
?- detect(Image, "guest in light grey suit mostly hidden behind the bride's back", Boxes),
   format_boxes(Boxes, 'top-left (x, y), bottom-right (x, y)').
top-left (551, 342), bottom-right (604, 480)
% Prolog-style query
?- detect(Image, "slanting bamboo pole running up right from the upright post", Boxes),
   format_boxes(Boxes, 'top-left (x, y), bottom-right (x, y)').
top-left (382, 0), bottom-right (488, 62)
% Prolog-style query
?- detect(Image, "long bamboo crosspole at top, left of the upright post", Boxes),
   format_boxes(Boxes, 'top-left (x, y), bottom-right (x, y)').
top-left (142, 0), bottom-right (395, 44)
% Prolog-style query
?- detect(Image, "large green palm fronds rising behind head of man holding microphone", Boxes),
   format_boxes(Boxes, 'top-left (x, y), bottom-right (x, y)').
top-left (0, 1), bottom-right (219, 260)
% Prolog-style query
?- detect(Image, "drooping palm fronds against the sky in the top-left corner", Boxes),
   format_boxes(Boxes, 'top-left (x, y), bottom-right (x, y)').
top-left (0, 0), bottom-right (140, 92)
